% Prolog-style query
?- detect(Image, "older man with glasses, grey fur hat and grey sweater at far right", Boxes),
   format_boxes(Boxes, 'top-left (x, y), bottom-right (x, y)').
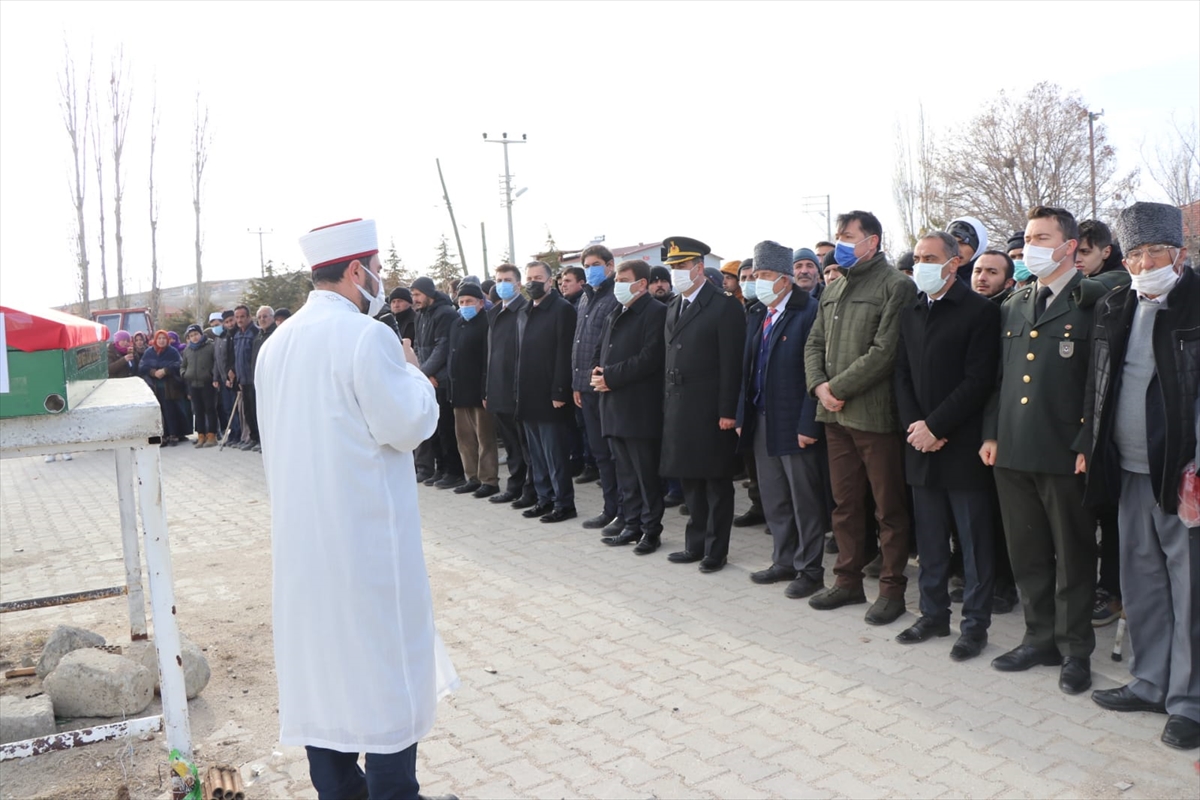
top-left (1080, 203), bottom-right (1200, 750)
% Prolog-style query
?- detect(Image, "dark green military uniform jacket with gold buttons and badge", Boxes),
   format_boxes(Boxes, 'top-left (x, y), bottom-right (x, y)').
top-left (983, 272), bottom-right (1129, 475)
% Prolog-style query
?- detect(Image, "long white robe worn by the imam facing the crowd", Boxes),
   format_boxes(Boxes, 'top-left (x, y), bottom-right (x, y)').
top-left (254, 290), bottom-right (458, 753)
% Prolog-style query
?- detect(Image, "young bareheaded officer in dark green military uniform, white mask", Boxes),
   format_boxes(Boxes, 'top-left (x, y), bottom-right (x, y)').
top-left (979, 206), bottom-right (1129, 694)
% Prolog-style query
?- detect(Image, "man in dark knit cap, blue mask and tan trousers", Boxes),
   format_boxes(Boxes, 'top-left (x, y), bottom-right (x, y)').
top-left (446, 283), bottom-right (500, 498)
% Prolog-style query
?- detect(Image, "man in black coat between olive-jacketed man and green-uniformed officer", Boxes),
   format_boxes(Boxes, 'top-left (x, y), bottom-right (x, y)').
top-left (895, 231), bottom-right (1000, 661)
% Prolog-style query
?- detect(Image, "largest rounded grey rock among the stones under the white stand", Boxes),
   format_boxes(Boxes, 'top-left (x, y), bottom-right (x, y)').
top-left (42, 650), bottom-right (154, 717)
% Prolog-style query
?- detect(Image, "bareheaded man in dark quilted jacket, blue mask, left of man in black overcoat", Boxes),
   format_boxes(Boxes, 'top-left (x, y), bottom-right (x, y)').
top-left (571, 245), bottom-right (623, 535)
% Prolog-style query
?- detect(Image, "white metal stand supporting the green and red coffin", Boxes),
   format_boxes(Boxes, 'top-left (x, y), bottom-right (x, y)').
top-left (0, 378), bottom-right (192, 760)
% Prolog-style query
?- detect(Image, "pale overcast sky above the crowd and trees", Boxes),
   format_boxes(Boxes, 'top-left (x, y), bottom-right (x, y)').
top-left (0, 0), bottom-right (1200, 306)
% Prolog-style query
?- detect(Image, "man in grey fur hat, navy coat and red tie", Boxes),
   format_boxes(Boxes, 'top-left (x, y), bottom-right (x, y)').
top-left (738, 241), bottom-right (828, 599)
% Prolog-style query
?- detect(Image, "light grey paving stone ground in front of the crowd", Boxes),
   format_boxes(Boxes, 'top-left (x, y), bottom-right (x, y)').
top-left (0, 447), bottom-right (1200, 798)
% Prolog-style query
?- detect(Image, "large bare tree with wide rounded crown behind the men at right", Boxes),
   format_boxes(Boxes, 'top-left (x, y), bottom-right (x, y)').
top-left (934, 82), bottom-right (1138, 231)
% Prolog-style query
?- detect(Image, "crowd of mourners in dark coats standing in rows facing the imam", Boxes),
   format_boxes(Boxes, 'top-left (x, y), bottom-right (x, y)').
top-left (110, 203), bottom-right (1200, 748)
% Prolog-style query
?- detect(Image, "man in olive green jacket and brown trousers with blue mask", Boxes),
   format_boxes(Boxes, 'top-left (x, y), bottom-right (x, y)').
top-left (804, 211), bottom-right (917, 625)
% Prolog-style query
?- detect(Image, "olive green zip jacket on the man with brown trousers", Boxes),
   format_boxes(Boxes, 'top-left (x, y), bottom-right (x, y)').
top-left (804, 253), bottom-right (917, 433)
